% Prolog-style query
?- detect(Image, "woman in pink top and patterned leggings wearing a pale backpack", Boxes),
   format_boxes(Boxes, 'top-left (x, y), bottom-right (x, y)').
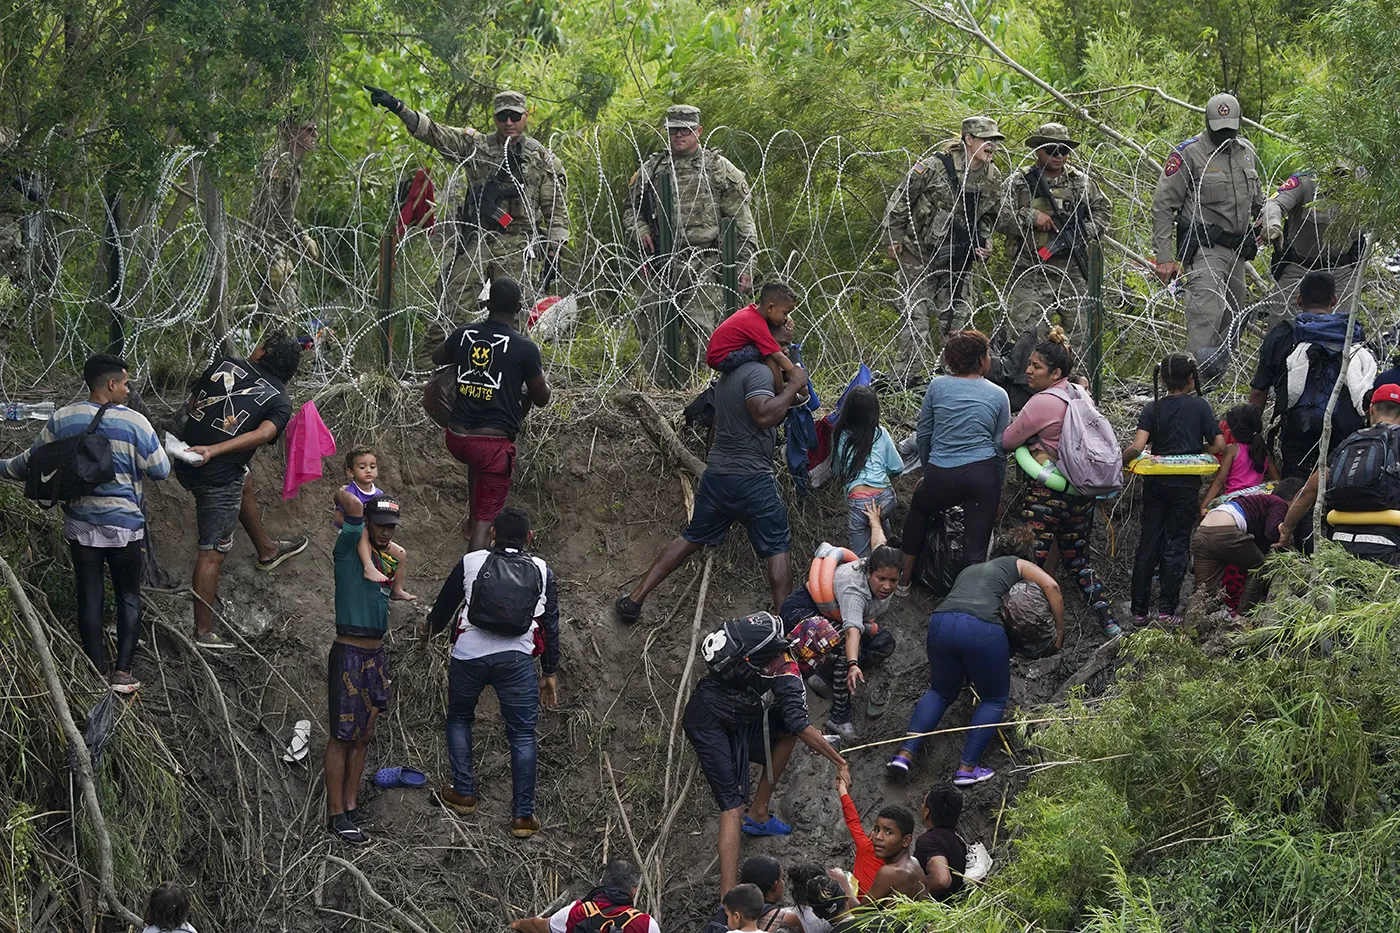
top-left (1001, 328), bottom-right (1123, 637)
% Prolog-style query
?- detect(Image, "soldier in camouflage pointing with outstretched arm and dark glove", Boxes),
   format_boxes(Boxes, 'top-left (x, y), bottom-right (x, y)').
top-left (368, 87), bottom-right (568, 324)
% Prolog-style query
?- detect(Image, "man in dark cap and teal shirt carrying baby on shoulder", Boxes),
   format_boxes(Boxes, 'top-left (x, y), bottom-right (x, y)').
top-left (325, 489), bottom-right (399, 845)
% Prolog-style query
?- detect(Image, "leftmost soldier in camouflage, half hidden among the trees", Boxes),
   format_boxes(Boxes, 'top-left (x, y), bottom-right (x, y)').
top-left (251, 119), bottom-right (321, 324)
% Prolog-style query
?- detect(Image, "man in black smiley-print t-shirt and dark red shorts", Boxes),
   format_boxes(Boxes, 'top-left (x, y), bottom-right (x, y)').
top-left (433, 277), bottom-right (550, 551)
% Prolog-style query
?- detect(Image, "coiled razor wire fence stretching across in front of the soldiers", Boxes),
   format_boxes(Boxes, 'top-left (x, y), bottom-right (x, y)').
top-left (0, 125), bottom-right (1397, 428)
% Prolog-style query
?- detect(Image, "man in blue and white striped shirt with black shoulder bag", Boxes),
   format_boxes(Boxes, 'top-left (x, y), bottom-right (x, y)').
top-left (0, 353), bottom-right (171, 693)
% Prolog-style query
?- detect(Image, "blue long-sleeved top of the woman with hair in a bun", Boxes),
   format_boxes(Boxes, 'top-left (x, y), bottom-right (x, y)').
top-left (918, 375), bottom-right (1011, 468)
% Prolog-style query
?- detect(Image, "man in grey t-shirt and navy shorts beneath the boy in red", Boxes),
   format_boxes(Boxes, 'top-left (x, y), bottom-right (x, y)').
top-left (613, 328), bottom-right (806, 625)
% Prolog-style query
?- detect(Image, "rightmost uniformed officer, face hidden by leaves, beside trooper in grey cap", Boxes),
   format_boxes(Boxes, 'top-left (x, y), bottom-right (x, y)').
top-left (1259, 165), bottom-right (1366, 315)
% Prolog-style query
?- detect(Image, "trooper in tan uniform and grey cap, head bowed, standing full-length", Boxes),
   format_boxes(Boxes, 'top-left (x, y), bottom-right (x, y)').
top-left (1152, 94), bottom-right (1264, 375)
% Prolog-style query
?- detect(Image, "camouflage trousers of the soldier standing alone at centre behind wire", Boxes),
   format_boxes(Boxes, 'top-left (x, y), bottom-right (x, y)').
top-left (637, 251), bottom-right (725, 385)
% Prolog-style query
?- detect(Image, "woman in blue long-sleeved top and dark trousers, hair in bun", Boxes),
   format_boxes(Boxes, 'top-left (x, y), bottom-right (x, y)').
top-left (899, 331), bottom-right (1011, 593)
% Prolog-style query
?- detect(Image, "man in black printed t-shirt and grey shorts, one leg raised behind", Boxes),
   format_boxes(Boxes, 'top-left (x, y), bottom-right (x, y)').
top-left (175, 331), bottom-right (307, 649)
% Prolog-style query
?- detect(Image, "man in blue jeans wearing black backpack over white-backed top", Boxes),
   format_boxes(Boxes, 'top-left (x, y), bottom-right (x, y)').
top-left (427, 509), bottom-right (559, 839)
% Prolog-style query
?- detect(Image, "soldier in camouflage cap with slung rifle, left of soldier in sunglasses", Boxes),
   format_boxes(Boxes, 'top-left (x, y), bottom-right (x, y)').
top-left (885, 116), bottom-right (1005, 374)
